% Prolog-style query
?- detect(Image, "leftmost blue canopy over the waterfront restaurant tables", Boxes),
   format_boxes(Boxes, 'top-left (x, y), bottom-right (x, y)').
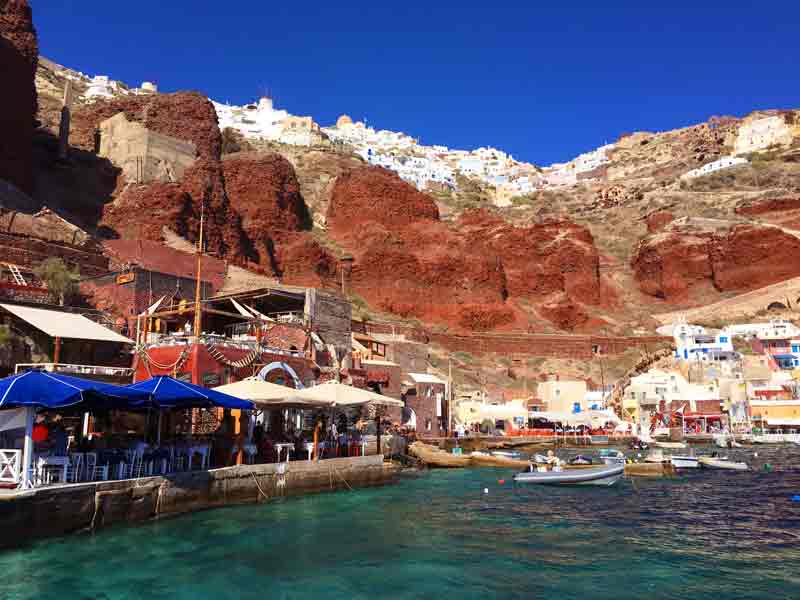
top-left (0, 371), bottom-right (149, 410)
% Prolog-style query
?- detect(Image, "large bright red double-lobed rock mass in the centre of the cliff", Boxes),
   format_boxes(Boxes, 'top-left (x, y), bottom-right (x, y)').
top-left (328, 167), bottom-right (515, 329)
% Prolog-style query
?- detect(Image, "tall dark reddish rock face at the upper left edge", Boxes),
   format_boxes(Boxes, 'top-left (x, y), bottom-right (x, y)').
top-left (0, 0), bottom-right (39, 194)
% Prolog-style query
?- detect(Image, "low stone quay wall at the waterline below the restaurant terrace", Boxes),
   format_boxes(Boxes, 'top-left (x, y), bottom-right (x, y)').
top-left (0, 455), bottom-right (397, 549)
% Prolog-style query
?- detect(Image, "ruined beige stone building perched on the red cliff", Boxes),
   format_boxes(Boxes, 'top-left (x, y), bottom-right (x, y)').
top-left (99, 112), bottom-right (197, 183)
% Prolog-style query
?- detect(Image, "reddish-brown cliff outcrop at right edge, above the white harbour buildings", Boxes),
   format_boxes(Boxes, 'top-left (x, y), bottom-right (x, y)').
top-left (631, 220), bottom-right (800, 301)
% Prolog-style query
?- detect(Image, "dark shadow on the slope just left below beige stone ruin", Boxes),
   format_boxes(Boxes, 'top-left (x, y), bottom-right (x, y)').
top-left (33, 130), bottom-right (121, 238)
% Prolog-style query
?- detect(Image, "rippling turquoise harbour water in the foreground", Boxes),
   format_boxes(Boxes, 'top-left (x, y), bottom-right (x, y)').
top-left (0, 449), bottom-right (800, 600)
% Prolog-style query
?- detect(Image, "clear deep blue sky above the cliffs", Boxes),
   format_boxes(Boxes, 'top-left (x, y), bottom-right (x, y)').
top-left (31, 0), bottom-right (800, 164)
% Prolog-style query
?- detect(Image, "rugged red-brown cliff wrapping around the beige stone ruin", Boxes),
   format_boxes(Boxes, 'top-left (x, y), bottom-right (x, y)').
top-left (72, 92), bottom-right (247, 262)
